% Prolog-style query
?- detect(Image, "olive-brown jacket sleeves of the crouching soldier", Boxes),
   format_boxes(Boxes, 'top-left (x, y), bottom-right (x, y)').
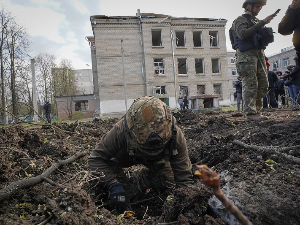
top-left (88, 119), bottom-right (193, 187)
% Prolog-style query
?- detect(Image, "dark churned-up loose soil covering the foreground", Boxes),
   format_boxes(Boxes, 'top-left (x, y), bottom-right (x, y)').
top-left (0, 109), bottom-right (300, 225)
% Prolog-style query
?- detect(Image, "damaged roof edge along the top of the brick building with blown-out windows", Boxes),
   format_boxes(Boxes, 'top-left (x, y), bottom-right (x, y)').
top-left (90, 13), bottom-right (228, 22)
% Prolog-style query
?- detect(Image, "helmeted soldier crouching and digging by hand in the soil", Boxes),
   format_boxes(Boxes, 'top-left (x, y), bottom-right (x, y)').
top-left (88, 96), bottom-right (194, 214)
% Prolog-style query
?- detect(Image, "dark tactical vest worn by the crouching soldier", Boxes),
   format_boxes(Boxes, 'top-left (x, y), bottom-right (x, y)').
top-left (124, 115), bottom-right (178, 164)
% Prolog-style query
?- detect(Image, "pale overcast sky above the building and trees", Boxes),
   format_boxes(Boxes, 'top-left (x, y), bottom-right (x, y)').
top-left (0, 0), bottom-right (292, 69)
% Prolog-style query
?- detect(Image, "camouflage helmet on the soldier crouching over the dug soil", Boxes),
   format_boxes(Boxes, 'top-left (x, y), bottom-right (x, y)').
top-left (126, 96), bottom-right (172, 149)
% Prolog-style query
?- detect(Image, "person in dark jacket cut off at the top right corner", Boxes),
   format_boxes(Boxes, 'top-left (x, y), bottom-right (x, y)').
top-left (278, 0), bottom-right (300, 63)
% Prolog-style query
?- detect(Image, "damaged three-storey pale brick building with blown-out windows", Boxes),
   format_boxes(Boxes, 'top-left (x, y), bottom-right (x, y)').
top-left (88, 10), bottom-right (231, 116)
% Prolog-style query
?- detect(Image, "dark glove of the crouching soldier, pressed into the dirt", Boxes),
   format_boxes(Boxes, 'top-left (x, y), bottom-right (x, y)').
top-left (108, 182), bottom-right (128, 214)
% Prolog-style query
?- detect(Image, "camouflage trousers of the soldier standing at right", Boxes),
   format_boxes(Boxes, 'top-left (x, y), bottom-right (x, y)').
top-left (236, 49), bottom-right (269, 115)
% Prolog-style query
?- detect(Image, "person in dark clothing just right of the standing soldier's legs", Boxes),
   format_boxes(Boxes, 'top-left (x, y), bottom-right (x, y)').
top-left (263, 60), bottom-right (278, 108)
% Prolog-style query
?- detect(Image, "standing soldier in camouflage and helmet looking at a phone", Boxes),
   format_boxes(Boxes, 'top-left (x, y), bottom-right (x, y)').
top-left (232, 0), bottom-right (276, 119)
